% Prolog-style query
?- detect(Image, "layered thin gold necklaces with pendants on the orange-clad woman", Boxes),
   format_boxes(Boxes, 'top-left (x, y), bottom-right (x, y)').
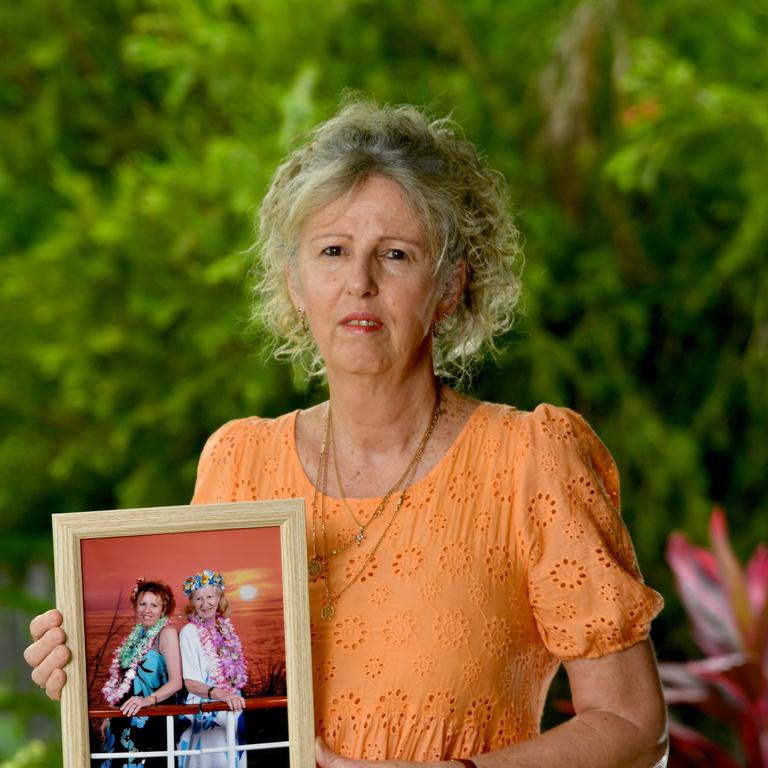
top-left (309, 383), bottom-right (441, 621)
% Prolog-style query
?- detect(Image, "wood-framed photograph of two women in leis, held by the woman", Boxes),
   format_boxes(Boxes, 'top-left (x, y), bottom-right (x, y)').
top-left (53, 500), bottom-right (315, 768)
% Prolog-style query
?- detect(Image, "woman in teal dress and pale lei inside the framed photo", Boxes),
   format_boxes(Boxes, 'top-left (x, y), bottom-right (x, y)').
top-left (101, 579), bottom-right (181, 768)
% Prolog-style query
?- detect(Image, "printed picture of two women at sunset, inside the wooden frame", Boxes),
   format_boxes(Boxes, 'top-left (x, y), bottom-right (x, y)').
top-left (83, 528), bottom-right (287, 768)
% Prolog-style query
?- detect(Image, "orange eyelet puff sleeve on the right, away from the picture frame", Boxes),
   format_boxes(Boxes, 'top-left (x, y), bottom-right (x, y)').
top-left (516, 405), bottom-right (663, 660)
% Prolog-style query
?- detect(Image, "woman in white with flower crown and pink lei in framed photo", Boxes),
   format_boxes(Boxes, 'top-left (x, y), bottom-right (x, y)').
top-left (179, 569), bottom-right (248, 768)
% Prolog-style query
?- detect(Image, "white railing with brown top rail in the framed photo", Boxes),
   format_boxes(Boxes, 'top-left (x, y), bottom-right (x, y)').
top-left (88, 696), bottom-right (288, 768)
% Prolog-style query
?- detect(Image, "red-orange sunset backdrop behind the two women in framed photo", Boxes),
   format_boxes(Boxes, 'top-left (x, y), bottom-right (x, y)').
top-left (81, 526), bottom-right (285, 705)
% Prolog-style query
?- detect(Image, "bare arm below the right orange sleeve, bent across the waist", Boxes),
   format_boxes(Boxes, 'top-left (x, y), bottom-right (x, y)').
top-left (317, 640), bottom-right (667, 768)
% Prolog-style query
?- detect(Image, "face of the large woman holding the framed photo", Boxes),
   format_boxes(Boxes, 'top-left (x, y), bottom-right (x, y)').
top-left (288, 176), bottom-right (458, 376)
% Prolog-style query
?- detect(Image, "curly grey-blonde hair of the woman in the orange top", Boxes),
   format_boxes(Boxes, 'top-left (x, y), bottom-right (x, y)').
top-left (252, 100), bottom-right (521, 380)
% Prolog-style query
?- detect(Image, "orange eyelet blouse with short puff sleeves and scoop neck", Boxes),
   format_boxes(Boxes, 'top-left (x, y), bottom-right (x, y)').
top-left (194, 403), bottom-right (663, 761)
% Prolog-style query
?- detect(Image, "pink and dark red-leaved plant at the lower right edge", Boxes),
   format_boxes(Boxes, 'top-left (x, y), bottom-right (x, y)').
top-left (660, 508), bottom-right (768, 768)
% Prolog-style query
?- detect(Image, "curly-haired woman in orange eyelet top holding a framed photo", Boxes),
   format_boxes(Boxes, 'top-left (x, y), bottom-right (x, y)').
top-left (29, 103), bottom-right (666, 768)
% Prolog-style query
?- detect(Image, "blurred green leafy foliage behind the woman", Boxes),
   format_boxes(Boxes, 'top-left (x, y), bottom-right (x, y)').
top-left (0, 0), bottom-right (768, 766)
